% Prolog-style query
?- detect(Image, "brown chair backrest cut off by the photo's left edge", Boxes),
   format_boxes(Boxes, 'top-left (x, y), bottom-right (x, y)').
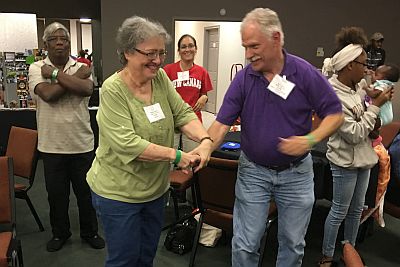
top-left (0, 156), bottom-right (15, 225)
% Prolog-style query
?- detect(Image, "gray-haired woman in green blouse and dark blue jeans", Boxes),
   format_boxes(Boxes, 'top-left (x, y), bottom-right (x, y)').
top-left (87, 16), bottom-right (212, 267)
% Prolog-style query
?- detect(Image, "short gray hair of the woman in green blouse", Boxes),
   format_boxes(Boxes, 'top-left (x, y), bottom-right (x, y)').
top-left (116, 16), bottom-right (171, 65)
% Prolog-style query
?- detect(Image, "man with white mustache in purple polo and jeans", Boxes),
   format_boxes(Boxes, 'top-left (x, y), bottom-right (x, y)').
top-left (208, 8), bottom-right (343, 267)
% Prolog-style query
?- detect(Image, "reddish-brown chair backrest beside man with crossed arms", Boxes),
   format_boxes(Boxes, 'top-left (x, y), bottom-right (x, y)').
top-left (6, 126), bottom-right (38, 184)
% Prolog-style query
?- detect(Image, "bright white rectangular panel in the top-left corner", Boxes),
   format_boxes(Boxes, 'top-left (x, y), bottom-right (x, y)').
top-left (0, 13), bottom-right (38, 52)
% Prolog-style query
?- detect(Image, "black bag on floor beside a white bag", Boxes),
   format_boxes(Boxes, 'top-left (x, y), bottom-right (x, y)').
top-left (164, 217), bottom-right (197, 255)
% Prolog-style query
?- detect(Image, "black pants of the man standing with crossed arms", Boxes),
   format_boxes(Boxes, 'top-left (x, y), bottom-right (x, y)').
top-left (41, 151), bottom-right (98, 238)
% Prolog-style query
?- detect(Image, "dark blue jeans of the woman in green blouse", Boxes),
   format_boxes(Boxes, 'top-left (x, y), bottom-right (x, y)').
top-left (92, 192), bottom-right (164, 267)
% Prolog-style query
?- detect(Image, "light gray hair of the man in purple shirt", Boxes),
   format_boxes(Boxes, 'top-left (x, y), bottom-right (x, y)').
top-left (240, 8), bottom-right (285, 46)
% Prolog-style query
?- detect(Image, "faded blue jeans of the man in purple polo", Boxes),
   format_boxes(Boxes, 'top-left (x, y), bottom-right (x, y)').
top-left (232, 152), bottom-right (314, 267)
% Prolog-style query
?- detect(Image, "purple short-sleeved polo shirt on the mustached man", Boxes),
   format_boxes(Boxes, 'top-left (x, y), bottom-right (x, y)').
top-left (217, 51), bottom-right (342, 166)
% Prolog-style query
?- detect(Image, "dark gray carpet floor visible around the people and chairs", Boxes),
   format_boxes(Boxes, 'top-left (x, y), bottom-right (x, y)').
top-left (16, 161), bottom-right (400, 267)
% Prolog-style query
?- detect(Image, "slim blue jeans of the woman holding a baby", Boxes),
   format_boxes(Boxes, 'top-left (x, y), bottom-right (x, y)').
top-left (322, 163), bottom-right (370, 257)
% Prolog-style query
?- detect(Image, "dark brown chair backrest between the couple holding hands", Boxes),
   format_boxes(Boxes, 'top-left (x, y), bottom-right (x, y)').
top-left (197, 157), bottom-right (238, 231)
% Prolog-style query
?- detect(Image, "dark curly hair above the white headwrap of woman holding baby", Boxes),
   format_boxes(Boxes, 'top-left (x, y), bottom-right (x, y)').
top-left (333, 26), bottom-right (368, 54)
